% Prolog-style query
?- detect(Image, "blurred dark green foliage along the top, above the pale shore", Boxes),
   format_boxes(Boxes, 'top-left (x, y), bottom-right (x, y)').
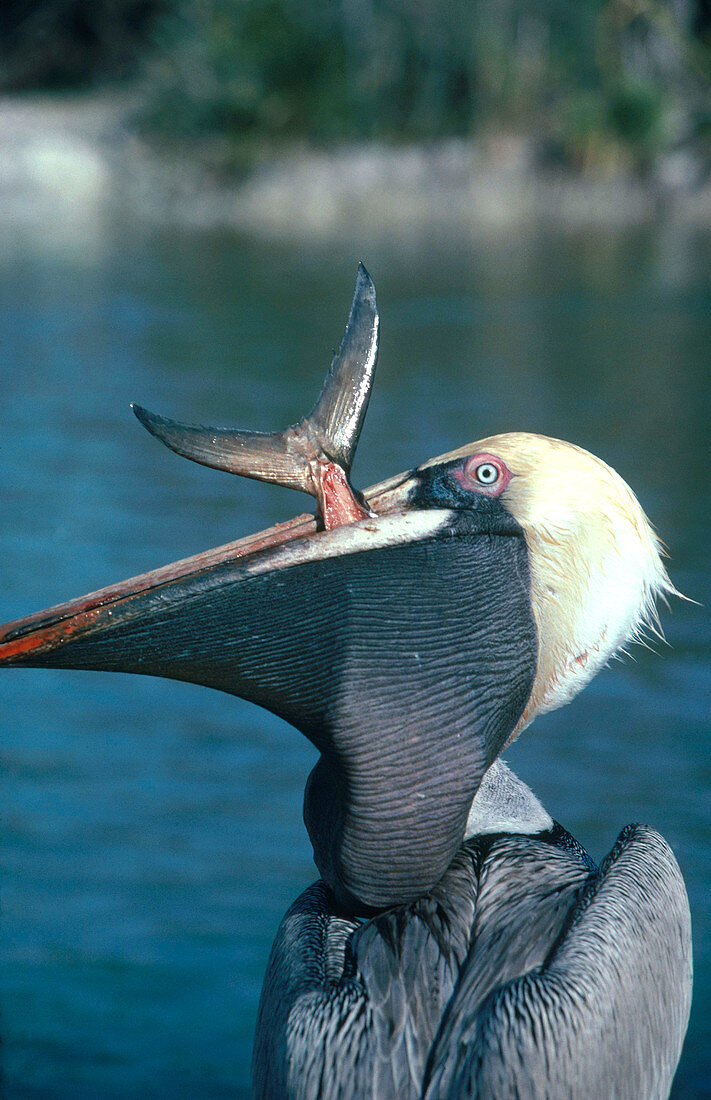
top-left (0, 0), bottom-right (711, 169)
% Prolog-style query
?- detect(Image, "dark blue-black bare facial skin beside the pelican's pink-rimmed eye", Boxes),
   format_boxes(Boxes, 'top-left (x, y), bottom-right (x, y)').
top-left (409, 458), bottom-right (523, 538)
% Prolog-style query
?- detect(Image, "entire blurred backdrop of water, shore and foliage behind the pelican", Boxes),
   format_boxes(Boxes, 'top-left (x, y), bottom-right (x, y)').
top-left (0, 0), bottom-right (711, 1100)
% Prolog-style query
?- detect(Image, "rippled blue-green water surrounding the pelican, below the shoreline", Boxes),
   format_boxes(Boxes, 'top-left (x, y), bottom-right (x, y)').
top-left (0, 223), bottom-right (711, 1100)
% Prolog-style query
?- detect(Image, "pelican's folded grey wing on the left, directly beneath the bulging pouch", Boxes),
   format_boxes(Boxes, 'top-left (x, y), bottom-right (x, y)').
top-left (252, 848), bottom-right (478, 1100)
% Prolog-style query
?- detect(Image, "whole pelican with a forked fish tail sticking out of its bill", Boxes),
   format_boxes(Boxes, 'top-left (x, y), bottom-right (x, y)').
top-left (0, 265), bottom-right (691, 1100)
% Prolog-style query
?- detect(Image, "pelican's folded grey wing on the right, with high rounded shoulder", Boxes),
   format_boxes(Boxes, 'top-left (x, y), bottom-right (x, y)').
top-left (423, 825), bottom-right (691, 1100)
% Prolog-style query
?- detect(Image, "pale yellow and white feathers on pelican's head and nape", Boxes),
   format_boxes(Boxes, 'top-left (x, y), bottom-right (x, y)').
top-left (427, 432), bottom-right (679, 739)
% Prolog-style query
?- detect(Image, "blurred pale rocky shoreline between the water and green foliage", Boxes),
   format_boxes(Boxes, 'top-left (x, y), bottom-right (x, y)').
top-left (0, 97), bottom-right (711, 239)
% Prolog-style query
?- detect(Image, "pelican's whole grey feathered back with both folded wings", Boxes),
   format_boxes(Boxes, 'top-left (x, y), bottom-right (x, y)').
top-left (253, 826), bottom-right (691, 1100)
